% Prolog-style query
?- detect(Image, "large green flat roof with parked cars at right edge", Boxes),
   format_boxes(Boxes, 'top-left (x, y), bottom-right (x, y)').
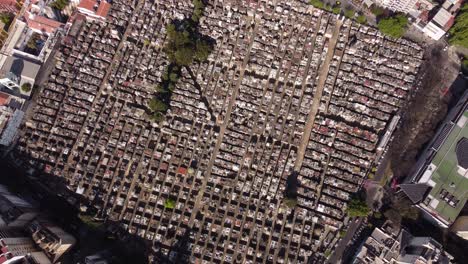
top-left (422, 109), bottom-right (468, 224)
